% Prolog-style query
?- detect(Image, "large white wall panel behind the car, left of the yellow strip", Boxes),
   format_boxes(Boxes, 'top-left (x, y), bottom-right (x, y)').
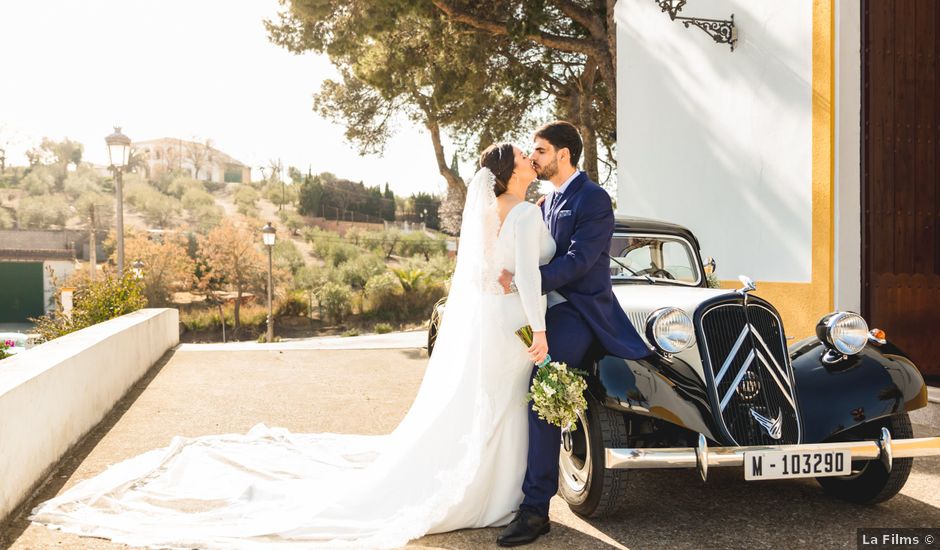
top-left (616, 0), bottom-right (812, 282)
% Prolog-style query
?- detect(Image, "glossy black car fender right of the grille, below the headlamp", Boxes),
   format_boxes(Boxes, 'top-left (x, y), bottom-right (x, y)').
top-left (790, 337), bottom-right (927, 443)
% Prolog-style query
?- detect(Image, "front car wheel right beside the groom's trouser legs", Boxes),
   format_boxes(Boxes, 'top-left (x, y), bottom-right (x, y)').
top-left (558, 393), bottom-right (628, 518)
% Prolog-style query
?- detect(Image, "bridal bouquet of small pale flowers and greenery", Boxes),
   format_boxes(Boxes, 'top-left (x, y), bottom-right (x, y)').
top-left (516, 325), bottom-right (587, 431)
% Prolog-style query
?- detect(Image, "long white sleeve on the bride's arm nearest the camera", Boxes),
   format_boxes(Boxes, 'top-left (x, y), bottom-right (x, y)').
top-left (513, 206), bottom-right (545, 331)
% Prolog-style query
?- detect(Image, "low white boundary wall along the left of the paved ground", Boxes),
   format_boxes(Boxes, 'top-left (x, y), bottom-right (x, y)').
top-left (0, 309), bottom-right (179, 520)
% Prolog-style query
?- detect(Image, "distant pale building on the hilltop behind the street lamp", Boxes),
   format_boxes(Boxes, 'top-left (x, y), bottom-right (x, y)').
top-left (133, 138), bottom-right (251, 187)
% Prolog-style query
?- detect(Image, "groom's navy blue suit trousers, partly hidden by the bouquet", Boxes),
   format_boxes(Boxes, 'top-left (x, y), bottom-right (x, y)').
top-left (520, 302), bottom-right (595, 517)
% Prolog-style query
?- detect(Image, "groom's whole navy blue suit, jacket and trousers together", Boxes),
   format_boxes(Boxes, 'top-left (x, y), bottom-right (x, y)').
top-left (522, 172), bottom-right (651, 516)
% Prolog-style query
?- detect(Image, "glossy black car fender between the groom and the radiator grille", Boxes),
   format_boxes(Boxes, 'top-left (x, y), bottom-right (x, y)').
top-left (588, 355), bottom-right (724, 441)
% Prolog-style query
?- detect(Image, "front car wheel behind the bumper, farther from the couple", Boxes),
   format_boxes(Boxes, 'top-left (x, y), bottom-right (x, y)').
top-left (816, 413), bottom-right (914, 504)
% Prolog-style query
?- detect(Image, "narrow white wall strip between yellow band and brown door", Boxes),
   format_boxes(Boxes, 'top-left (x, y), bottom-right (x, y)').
top-left (835, 0), bottom-right (862, 311)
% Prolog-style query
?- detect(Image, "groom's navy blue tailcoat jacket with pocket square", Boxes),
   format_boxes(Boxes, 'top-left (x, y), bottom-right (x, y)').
top-left (541, 172), bottom-right (651, 359)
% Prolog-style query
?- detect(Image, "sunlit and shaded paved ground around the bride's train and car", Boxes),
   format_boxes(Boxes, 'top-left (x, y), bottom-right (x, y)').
top-left (0, 346), bottom-right (940, 550)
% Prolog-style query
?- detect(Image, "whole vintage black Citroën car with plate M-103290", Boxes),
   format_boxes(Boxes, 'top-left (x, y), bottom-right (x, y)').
top-left (428, 218), bottom-right (940, 517)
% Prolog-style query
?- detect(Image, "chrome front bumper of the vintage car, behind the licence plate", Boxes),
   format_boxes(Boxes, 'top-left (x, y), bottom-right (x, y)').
top-left (604, 428), bottom-right (940, 480)
